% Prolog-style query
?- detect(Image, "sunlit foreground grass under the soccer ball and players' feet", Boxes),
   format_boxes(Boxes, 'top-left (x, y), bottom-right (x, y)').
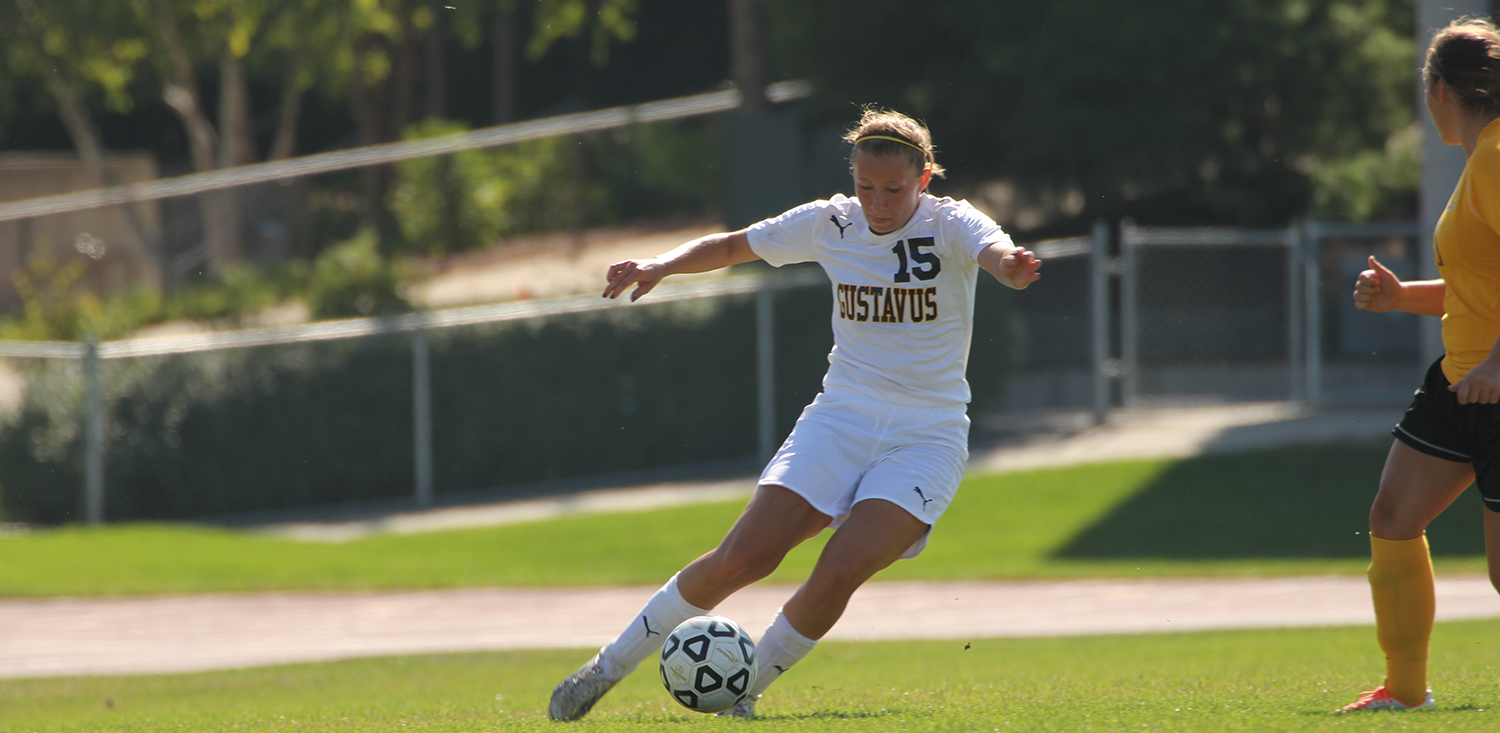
top-left (0, 622), bottom-right (1500, 733)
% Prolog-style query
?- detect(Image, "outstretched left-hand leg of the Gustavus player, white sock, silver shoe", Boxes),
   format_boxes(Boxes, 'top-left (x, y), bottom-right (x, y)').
top-left (548, 486), bottom-right (831, 721)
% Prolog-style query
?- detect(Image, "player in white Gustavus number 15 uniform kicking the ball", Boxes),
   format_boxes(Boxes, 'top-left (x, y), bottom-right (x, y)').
top-left (548, 109), bottom-right (1041, 721)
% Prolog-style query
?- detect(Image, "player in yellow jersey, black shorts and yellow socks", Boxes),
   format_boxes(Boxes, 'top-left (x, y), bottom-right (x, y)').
top-left (1344, 19), bottom-right (1500, 711)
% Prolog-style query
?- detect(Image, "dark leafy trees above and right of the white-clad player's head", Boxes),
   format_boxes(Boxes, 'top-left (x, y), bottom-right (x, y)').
top-left (771, 0), bottom-right (1415, 225)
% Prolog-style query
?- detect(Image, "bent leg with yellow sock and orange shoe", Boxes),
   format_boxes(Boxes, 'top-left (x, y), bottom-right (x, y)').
top-left (1343, 438), bottom-right (1475, 712)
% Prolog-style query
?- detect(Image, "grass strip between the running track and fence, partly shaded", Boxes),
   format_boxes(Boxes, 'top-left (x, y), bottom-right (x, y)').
top-left (0, 445), bottom-right (1484, 597)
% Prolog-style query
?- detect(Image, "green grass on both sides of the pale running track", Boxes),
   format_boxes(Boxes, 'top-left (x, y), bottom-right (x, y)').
top-left (0, 444), bottom-right (1500, 733)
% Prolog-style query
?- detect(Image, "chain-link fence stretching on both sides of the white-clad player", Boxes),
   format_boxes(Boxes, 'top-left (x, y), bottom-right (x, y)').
top-left (0, 222), bottom-right (1422, 522)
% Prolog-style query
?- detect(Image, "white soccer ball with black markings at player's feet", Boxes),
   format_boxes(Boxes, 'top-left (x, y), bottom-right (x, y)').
top-left (659, 616), bottom-right (755, 712)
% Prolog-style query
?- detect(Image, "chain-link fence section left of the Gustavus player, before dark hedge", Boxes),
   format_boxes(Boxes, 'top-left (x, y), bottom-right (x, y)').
top-left (0, 268), bottom-right (831, 523)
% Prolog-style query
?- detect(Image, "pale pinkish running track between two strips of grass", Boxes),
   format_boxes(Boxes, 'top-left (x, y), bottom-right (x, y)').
top-left (0, 576), bottom-right (1500, 678)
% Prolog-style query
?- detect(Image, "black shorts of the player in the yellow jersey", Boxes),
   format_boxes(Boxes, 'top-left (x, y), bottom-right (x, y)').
top-left (1391, 358), bottom-right (1500, 511)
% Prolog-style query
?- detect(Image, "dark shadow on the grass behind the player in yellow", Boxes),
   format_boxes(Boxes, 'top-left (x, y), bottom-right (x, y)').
top-left (1055, 442), bottom-right (1485, 561)
